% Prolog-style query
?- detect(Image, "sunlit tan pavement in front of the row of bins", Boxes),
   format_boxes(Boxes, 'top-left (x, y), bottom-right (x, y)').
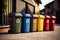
top-left (0, 25), bottom-right (60, 40)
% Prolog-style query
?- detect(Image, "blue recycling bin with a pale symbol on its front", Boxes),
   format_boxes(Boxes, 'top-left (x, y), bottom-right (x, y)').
top-left (21, 13), bottom-right (31, 33)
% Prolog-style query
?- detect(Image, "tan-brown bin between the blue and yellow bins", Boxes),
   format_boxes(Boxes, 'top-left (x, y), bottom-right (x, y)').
top-left (31, 14), bottom-right (38, 32)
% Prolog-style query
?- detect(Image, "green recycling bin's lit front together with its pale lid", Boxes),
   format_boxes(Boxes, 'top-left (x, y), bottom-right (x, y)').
top-left (13, 13), bottom-right (22, 33)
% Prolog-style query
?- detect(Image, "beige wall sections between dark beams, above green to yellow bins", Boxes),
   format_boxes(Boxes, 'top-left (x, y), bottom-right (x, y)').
top-left (16, 0), bottom-right (40, 13)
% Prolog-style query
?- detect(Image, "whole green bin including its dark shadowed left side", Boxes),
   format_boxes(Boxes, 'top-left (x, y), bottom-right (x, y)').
top-left (10, 13), bottom-right (22, 33)
